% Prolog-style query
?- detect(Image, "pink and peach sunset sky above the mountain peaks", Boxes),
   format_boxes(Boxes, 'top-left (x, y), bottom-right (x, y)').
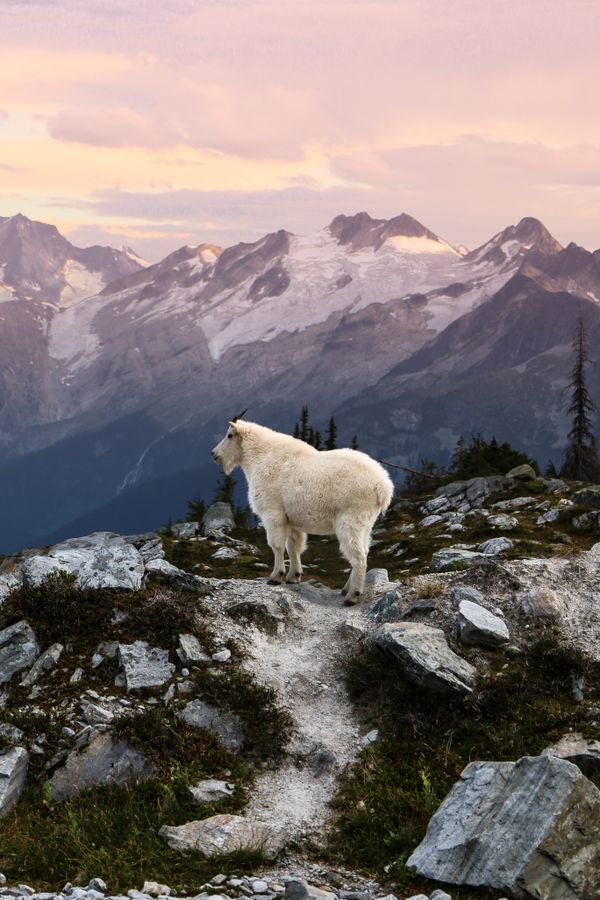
top-left (0, 0), bottom-right (600, 260)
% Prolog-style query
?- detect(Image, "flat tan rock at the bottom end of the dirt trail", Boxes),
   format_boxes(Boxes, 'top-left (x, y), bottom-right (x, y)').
top-left (158, 815), bottom-right (284, 859)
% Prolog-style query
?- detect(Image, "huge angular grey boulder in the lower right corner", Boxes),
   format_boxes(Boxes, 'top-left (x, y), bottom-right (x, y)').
top-left (407, 756), bottom-right (600, 900)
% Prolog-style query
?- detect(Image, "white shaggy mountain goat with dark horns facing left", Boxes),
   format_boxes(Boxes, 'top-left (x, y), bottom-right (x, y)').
top-left (211, 418), bottom-right (394, 603)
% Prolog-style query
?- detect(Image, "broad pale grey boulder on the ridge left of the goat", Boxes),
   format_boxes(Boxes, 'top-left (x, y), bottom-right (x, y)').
top-left (23, 531), bottom-right (144, 590)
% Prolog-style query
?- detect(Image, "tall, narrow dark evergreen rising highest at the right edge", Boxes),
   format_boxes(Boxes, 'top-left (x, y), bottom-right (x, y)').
top-left (560, 315), bottom-right (600, 481)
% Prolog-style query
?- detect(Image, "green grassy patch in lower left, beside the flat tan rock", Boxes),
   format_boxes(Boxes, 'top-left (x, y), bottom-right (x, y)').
top-left (0, 778), bottom-right (264, 894)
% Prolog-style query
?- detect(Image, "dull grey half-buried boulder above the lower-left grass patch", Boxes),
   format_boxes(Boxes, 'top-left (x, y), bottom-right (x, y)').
top-left (50, 733), bottom-right (153, 800)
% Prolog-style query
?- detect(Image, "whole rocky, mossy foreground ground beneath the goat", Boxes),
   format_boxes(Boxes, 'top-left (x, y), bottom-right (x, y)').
top-left (0, 467), bottom-right (600, 900)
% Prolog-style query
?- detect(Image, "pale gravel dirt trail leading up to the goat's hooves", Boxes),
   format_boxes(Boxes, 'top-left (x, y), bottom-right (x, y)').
top-left (207, 581), bottom-right (364, 839)
